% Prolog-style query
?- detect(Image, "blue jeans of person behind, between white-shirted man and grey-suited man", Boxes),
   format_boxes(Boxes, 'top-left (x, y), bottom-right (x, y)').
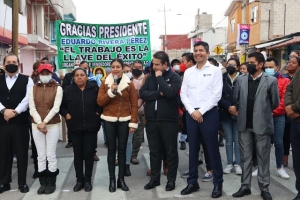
top-left (221, 118), bottom-right (241, 165)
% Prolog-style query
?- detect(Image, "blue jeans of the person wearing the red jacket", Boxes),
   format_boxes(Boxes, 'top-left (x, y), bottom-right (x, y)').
top-left (272, 115), bottom-right (285, 168)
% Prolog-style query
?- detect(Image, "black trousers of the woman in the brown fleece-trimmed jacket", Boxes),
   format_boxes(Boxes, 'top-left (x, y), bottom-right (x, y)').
top-left (104, 121), bottom-right (129, 178)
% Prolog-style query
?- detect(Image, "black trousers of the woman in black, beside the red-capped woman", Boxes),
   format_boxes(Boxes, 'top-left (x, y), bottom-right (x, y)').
top-left (69, 131), bottom-right (97, 183)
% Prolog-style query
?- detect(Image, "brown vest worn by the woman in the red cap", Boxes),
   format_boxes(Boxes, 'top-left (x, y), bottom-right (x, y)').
top-left (31, 81), bottom-right (60, 124)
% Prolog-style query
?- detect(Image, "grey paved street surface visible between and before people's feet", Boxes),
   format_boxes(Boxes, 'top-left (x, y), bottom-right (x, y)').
top-left (0, 131), bottom-right (296, 200)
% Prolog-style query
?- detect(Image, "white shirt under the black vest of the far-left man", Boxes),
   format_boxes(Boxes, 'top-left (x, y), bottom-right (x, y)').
top-left (0, 73), bottom-right (34, 114)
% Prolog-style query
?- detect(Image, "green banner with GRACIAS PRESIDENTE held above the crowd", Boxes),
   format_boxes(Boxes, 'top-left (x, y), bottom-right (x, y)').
top-left (56, 20), bottom-right (152, 69)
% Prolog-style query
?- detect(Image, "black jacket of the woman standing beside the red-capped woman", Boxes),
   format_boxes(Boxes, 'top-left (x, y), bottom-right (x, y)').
top-left (60, 81), bottom-right (102, 131)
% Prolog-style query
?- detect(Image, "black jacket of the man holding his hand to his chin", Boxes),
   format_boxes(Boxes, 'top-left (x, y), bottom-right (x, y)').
top-left (140, 68), bottom-right (181, 121)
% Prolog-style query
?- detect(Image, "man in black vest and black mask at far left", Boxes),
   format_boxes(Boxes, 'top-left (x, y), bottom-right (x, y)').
top-left (0, 54), bottom-right (33, 193)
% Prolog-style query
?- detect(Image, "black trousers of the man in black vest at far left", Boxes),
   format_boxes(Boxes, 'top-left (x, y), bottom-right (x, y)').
top-left (0, 124), bottom-right (30, 185)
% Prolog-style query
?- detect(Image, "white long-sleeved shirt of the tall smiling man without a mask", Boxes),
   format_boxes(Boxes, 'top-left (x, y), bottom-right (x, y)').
top-left (180, 61), bottom-right (223, 115)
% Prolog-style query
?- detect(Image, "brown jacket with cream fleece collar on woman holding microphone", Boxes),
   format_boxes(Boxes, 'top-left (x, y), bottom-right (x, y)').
top-left (97, 74), bottom-right (138, 128)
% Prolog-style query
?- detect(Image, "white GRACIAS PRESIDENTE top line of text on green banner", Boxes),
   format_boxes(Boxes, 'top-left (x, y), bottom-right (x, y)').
top-left (60, 22), bottom-right (148, 39)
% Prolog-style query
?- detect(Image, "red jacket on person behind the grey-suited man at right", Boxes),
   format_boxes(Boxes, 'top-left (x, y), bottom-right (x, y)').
top-left (273, 74), bottom-right (290, 116)
